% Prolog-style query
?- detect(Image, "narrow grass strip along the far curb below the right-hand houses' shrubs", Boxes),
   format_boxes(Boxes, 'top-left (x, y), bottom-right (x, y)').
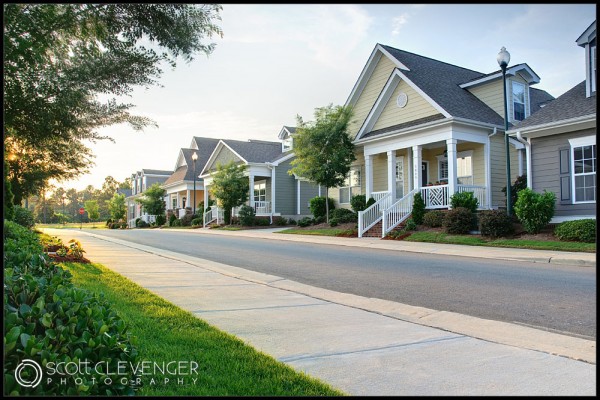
top-left (404, 232), bottom-right (596, 253)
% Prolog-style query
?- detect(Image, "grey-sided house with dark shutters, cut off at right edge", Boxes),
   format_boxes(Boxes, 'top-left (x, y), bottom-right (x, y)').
top-left (508, 21), bottom-right (597, 223)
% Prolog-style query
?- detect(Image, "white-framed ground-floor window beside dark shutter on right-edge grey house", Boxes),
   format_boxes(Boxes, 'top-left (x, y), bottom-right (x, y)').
top-left (572, 144), bottom-right (596, 203)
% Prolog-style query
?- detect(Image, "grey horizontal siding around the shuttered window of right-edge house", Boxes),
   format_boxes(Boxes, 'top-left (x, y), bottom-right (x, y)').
top-left (531, 129), bottom-right (596, 217)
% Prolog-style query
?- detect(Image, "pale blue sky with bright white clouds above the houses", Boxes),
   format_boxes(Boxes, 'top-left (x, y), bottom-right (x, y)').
top-left (56, 4), bottom-right (596, 190)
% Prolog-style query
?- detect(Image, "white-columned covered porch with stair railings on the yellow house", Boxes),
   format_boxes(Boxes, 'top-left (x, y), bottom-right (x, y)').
top-left (359, 132), bottom-right (491, 237)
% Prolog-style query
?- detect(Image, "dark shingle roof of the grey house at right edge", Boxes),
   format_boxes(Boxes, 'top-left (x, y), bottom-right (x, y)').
top-left (510, 81), bottom-right (596, 131)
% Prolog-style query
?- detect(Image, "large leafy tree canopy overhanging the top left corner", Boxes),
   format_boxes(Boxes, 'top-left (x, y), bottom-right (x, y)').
top-left (3, 3), bottom-right (222, 202)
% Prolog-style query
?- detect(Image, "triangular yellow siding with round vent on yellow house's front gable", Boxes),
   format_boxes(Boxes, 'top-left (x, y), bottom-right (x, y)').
top-left (373, 81), bottom-right (439, 130)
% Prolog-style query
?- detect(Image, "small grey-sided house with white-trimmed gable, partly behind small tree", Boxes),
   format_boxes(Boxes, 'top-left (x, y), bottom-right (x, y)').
top-left (200, 126), bottom-right (320, 226)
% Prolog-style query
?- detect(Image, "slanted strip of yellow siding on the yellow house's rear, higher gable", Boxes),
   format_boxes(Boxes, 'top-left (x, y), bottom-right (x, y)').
top-left (348, 56), bottom-right (395, 138)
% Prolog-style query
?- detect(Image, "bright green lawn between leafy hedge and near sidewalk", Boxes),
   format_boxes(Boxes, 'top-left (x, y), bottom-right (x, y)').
top-left (63, 263), bottom-right (344, 396)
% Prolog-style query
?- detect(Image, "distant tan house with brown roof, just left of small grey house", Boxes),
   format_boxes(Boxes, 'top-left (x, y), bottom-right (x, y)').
top-left (162, 136), bottom-right (219, 218)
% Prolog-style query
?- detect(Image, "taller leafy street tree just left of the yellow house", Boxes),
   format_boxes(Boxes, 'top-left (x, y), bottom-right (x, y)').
top-left (288, 104), bottom-right (356, 222)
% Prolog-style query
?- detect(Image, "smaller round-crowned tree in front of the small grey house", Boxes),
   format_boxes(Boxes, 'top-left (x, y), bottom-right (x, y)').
top-left (210, 161), bottom-right (249, 224)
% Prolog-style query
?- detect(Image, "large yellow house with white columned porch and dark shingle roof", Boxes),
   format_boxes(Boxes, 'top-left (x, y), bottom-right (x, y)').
top-left (330, 44), bottom-right (553, 236)
